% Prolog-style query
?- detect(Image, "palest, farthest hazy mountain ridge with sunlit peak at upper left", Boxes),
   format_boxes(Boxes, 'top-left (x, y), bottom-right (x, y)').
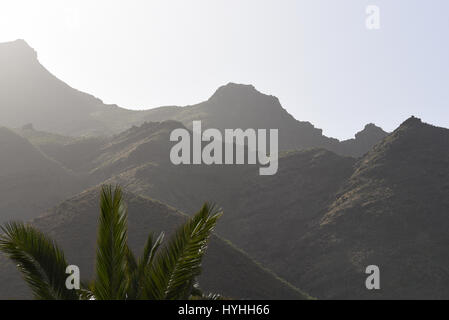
top-left (0, 40), bottom-right (381, 157)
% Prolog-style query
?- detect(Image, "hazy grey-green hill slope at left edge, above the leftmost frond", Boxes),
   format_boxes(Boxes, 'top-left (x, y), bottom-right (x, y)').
top-left (0, 128), bottom-right (83, 221)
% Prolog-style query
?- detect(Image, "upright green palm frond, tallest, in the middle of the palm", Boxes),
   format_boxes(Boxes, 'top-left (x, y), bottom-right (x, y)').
top-left (94, 186), bottom-right (130, 300)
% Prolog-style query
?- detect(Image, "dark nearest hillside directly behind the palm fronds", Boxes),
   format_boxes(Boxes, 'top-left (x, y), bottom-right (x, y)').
top-left (0, 188), bottom-right (308, 299)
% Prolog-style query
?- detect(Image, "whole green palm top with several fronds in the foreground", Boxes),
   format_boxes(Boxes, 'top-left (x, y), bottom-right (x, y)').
top-left (0, 186), bottom-right (222, 300)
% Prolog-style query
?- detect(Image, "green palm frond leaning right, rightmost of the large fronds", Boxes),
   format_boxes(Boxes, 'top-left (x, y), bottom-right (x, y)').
top-left (144, 204), bottom-right (221, 300)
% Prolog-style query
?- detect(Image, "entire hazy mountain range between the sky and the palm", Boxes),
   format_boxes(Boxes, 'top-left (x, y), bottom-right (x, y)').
top-left (0, 40), bottom-right (449, 299)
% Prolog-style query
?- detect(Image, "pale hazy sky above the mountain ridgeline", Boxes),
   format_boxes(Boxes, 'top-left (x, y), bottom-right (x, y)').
top-left (0, 0), bottom-right (449, 139)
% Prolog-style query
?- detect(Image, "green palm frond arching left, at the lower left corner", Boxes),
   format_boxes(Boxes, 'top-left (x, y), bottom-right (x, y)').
top-left (0, 222), bottom-right (79, 300)
